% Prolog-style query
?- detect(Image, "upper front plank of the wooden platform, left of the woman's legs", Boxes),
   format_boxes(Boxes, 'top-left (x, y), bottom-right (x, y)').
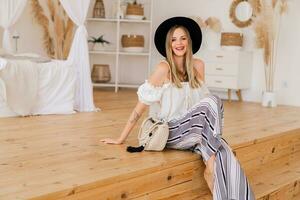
top-left (34, 161), bottom-right (201, 200)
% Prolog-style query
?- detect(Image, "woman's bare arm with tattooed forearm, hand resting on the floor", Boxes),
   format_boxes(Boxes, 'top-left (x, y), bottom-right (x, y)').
top-left (100, 62), bottom-right (169, 144)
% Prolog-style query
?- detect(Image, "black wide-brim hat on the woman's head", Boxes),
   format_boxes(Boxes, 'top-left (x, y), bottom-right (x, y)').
top-left (154, 17), bottom-right (202, 57)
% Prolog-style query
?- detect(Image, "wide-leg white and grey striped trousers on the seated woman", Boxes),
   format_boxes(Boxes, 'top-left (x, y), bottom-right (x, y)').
top-left (166, 95), bottom-right (255, 200)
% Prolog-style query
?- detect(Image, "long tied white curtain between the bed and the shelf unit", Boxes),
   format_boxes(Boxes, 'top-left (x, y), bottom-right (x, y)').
top-left (60, 0), bottom-right (95, 112)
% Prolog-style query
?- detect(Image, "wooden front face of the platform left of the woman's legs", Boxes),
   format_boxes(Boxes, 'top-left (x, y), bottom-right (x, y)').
top-left (35, 160), bottom-right (207, 200)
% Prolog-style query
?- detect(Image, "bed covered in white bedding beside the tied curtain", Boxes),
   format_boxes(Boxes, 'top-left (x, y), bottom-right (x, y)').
top-left (0, 56), bottom-right (76, 117)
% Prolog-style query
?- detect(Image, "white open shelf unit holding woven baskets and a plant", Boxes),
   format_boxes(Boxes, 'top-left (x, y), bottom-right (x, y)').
top-left (87, 0), bottom-right (153, 92)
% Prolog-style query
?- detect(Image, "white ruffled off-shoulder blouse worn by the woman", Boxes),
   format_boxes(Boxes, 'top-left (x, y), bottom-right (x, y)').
top-left (137, 80), bottom-right (210, 121)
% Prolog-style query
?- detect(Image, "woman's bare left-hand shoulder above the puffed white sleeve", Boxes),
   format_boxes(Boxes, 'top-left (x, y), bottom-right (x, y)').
top-left (149, 62), bottom-right (169, 86)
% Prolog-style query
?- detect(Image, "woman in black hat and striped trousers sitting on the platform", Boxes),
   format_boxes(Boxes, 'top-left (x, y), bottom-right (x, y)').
top-left (101, 17), bottom-right (254, 200)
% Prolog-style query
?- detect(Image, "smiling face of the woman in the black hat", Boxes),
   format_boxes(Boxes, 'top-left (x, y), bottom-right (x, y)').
top-left (171, 28), bottom-right (188, 56)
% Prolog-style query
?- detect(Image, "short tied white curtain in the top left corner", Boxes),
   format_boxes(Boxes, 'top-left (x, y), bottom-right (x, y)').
top-left (0, 0), bottom-right (27, 52)
